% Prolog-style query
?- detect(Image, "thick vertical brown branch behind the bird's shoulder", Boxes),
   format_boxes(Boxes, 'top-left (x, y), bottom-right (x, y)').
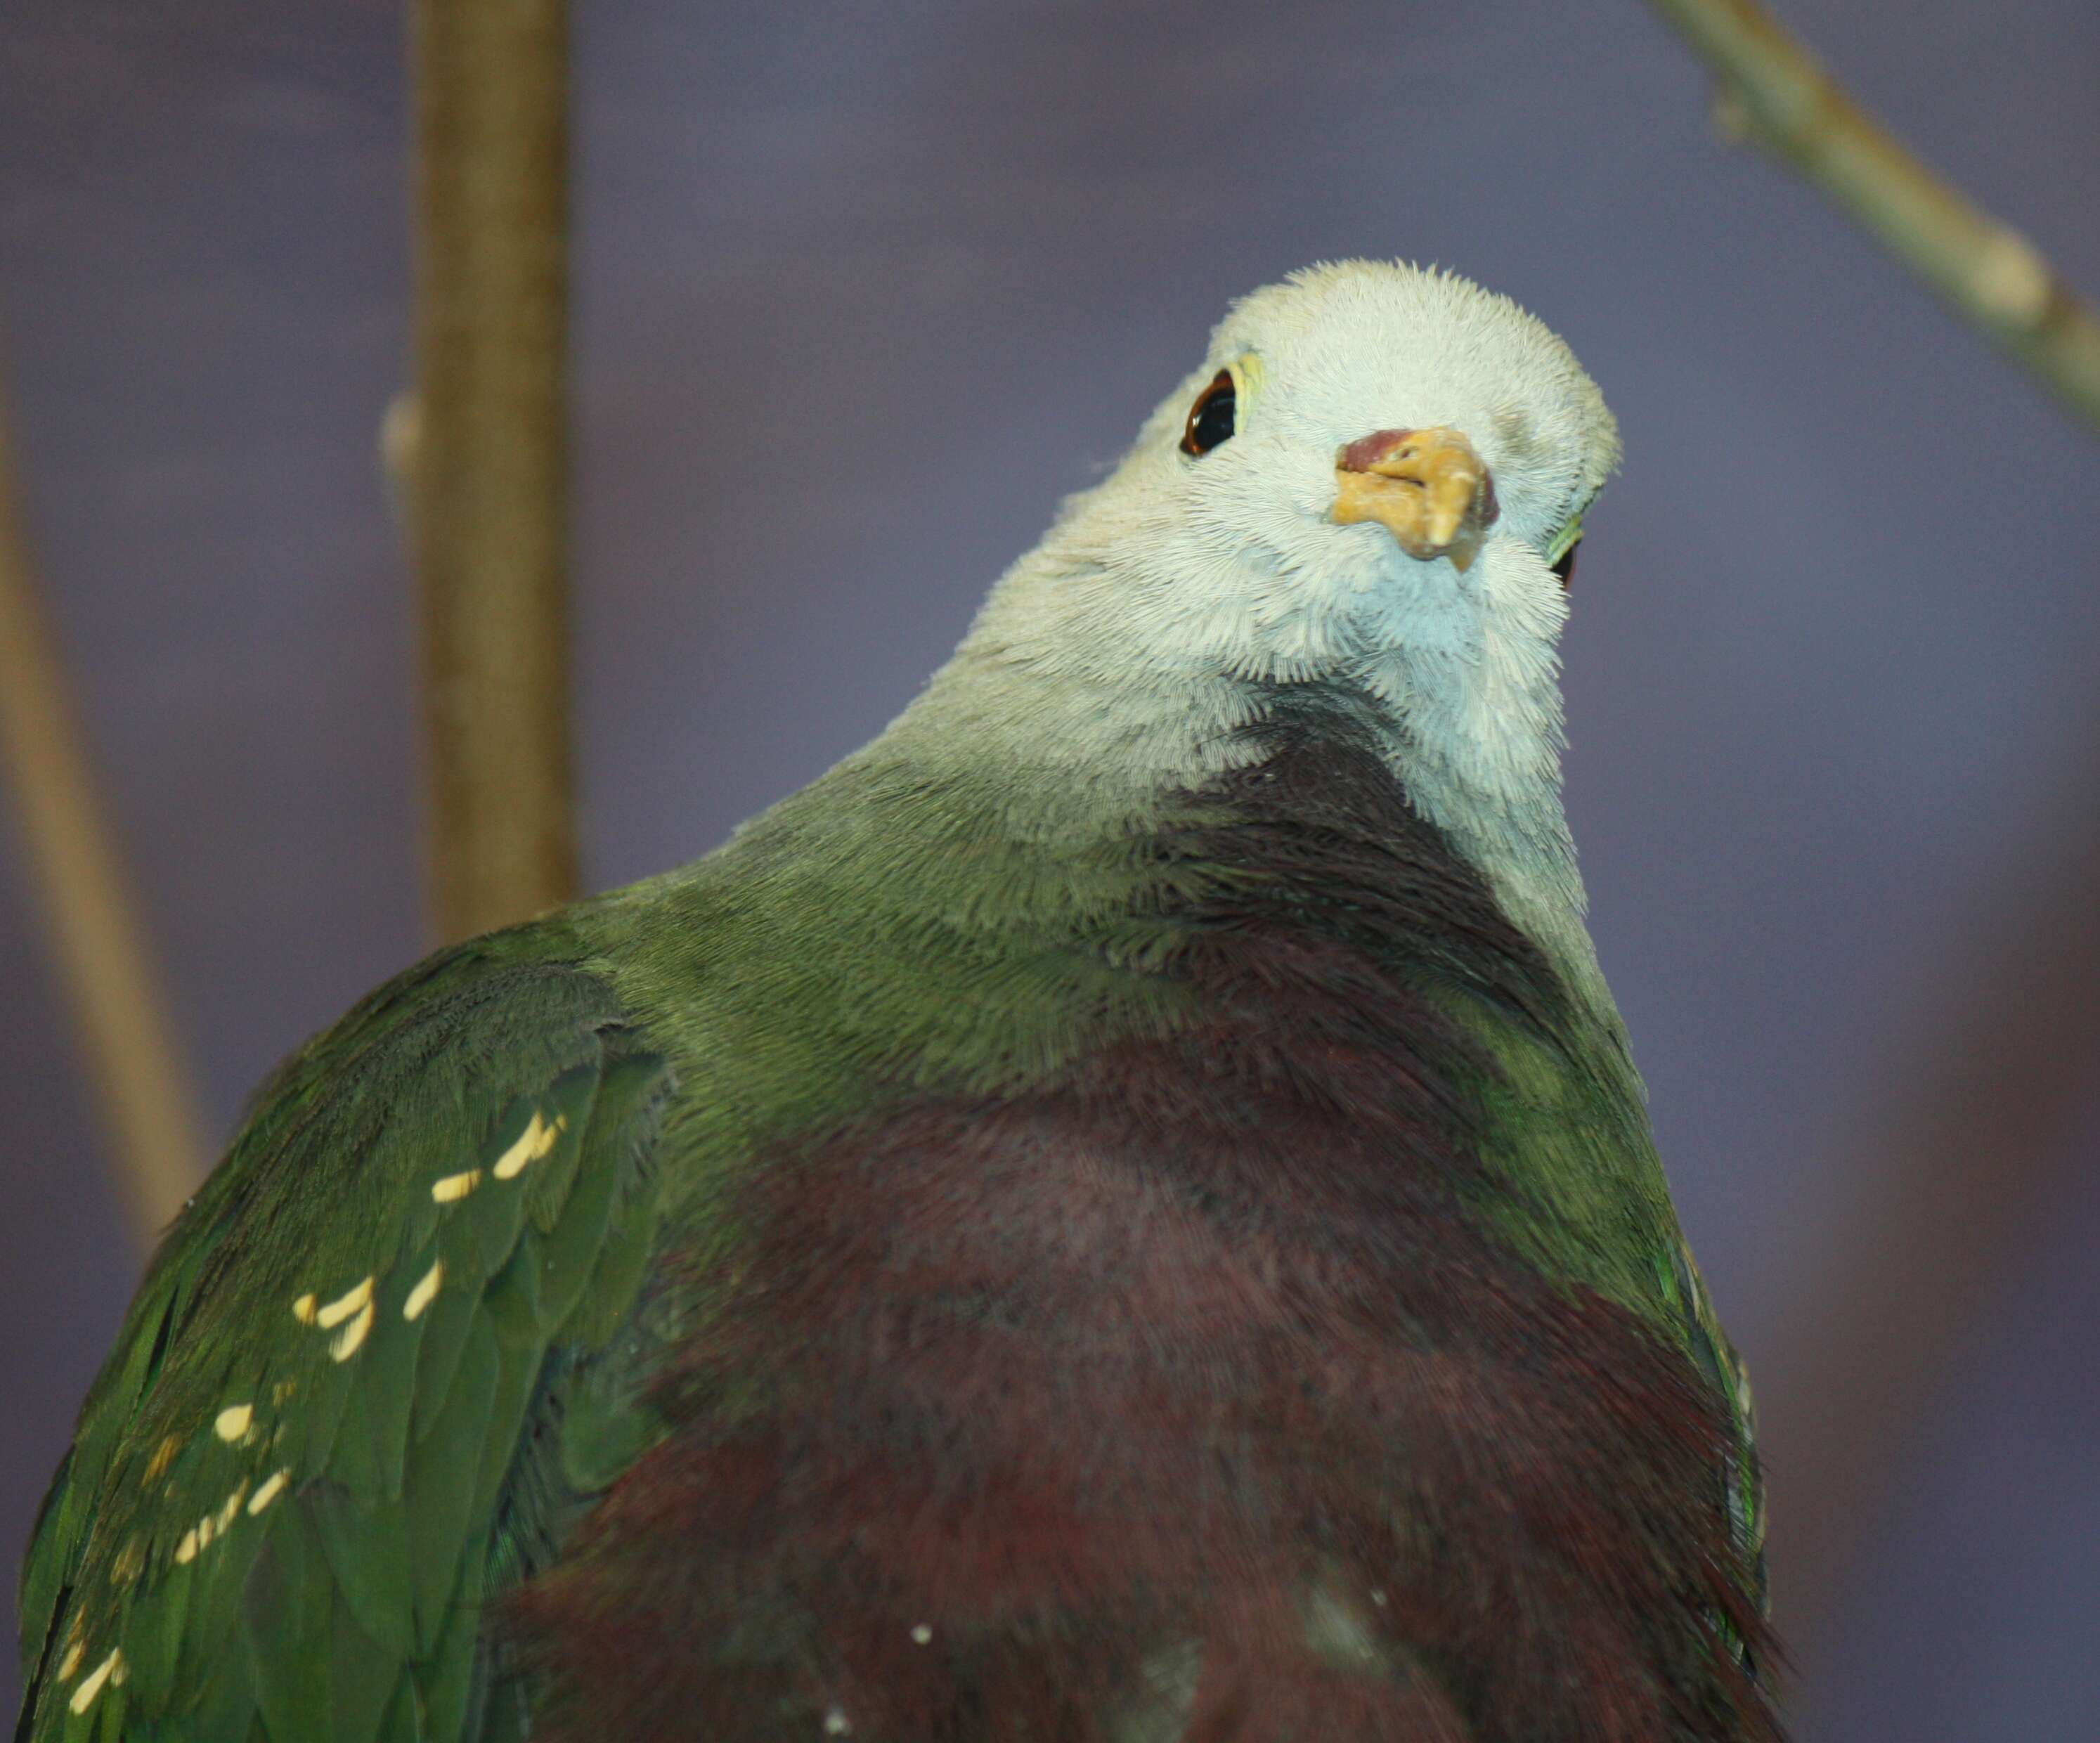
top-left (403, 0), bottom-right (576, 939)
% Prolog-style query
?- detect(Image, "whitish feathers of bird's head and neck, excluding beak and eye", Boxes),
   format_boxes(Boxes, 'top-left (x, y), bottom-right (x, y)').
top-left (899, 261), bottom-right (1619, 980)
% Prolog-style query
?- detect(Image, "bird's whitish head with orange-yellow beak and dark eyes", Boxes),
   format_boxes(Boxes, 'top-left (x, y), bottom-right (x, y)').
top-left (1050, 261), bottom-right (1619, 682)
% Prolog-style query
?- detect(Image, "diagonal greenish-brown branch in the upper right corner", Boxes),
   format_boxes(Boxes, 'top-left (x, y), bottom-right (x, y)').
top-left (1649, 0), bottom-right (2100, 433)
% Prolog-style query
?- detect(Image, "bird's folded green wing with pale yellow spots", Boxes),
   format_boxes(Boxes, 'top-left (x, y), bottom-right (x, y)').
top-left (17, 931), bottom-right (670, 1743)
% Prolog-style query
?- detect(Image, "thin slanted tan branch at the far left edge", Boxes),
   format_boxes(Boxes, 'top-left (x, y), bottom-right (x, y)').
top-left (0, 369), bottom-right (204, 1243)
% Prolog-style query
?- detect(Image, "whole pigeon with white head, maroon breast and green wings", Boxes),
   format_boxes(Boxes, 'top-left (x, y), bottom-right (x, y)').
top-left (17, 261), bottom-right (1781, 1743)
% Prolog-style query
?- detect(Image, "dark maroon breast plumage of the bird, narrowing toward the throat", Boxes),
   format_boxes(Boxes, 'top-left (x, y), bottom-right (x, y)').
top-left (510, 735), bottom-right (1777, 1743)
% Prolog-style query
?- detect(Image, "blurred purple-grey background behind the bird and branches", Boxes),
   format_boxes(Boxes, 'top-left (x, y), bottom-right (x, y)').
top-left (0, 0), bottom-right (2100, 1743)
